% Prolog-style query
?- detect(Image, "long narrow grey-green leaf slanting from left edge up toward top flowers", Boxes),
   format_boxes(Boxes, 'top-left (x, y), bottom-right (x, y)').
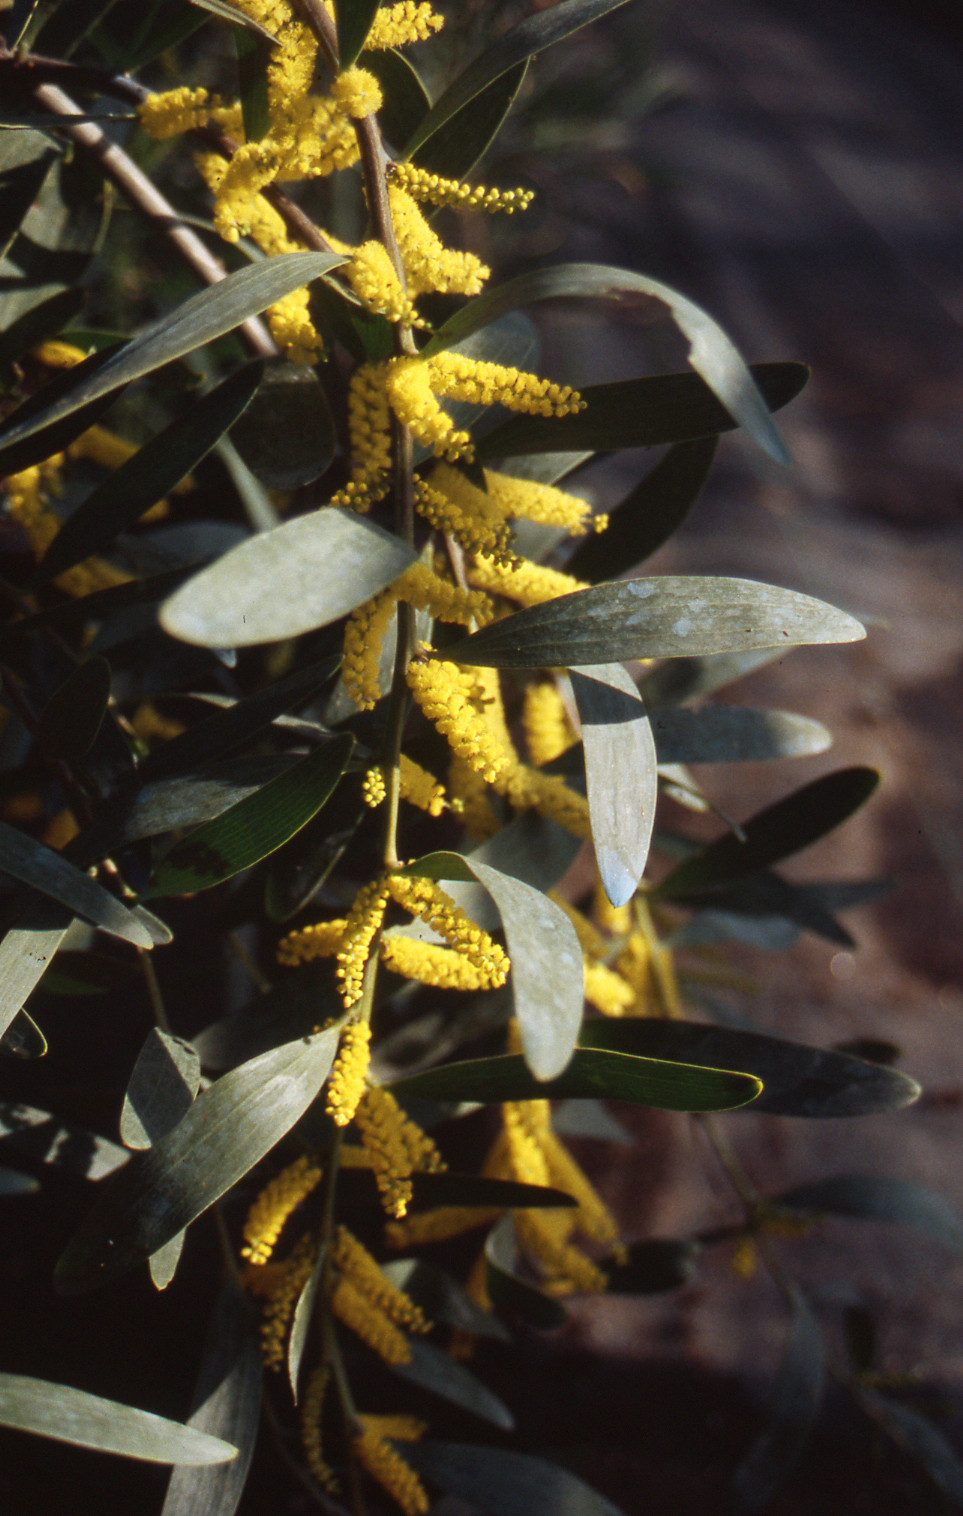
top-left (0, 253), bottom-right (344, 447)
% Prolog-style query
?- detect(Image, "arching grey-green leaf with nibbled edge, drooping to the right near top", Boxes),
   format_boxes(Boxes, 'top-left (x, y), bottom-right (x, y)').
top-left (429, 264), bottom-right (790, 464)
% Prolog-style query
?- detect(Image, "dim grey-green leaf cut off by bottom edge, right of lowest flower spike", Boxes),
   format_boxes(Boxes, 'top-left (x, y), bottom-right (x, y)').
top-left (405, 1442), bottom-right (622, 1516)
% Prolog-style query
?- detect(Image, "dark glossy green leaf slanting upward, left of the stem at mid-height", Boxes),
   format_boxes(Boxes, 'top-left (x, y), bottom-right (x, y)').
top-left (143, 732), bottom-right (355, 899)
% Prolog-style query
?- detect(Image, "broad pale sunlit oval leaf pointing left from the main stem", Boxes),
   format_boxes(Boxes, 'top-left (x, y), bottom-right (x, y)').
top-left (161, 506), bottom-right (417, 647)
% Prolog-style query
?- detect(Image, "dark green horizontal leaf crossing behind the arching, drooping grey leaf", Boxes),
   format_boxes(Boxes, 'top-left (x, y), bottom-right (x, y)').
top-left (473, 362), bottom-right (808, 464)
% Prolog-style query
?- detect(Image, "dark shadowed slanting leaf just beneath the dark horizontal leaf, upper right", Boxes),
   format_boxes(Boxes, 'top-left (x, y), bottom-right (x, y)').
top-left (566, 437), bottom-right (719, 584)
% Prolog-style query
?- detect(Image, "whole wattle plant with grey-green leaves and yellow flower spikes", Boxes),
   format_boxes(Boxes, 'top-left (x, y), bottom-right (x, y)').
top-left (0, 0), bottom-right (960, 1516)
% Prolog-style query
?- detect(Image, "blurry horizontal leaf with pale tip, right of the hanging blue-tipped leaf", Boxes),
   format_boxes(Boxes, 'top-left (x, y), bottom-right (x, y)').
top-left (651, 705), bottom-right (833, 764)
